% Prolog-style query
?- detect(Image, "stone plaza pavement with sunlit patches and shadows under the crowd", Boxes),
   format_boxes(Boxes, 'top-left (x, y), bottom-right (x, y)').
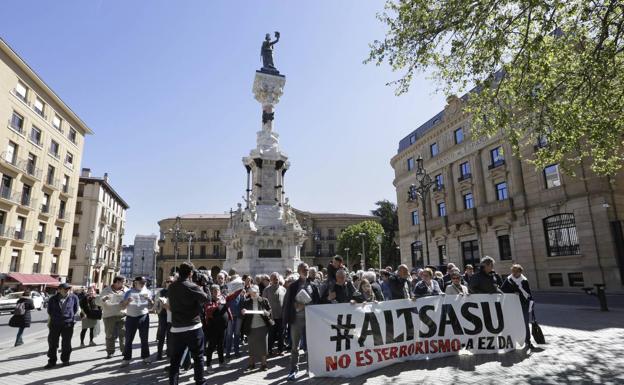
top-left (0, 305), bottom-right (624, 385)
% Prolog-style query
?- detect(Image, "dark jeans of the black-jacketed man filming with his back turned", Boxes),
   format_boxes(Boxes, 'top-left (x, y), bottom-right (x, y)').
top-left (169, 328), bottom-right (204, 385)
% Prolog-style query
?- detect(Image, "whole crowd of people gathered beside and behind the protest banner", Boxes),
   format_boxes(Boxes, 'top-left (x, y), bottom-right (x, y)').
top-left (4, 256), bottom-right (533, 384)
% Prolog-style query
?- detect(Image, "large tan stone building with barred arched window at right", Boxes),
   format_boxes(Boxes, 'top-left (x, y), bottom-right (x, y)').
top-left (391, 97), bottom-right (624, 291)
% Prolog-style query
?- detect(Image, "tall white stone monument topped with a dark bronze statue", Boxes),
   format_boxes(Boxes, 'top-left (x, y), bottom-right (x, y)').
top-left (224, 32), bottom-right (306, 274)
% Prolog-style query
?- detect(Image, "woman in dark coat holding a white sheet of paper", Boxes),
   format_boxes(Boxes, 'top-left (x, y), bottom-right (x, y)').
top-left (241, 285), bottom-right (274, 371)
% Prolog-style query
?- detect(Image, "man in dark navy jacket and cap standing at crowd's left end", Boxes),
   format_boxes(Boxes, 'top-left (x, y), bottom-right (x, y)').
top-left (44, 283), bottom-right (79, 369)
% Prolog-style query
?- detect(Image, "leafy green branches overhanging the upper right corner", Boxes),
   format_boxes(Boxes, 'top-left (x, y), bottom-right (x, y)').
top-left (367, 0), bottom-right (624, 175)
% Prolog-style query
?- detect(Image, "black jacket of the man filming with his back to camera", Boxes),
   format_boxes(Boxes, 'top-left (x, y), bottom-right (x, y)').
top-left (167, 278), bottom-right (208, 327)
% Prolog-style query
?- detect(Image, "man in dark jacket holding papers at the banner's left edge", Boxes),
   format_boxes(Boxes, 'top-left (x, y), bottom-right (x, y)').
top-left (282, 262), bottom-right (321, 381)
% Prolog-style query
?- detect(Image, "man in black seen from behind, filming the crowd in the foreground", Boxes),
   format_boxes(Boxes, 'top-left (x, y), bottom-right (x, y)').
top-left (167, 262), bottom-right (210, 385)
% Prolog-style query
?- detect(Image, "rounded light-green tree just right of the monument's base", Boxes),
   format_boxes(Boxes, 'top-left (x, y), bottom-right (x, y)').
top-left (338, 221), bottom-right (384, 268)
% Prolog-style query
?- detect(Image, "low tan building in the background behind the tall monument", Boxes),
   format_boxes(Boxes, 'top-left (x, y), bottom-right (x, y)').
top-left (157, 209), bottom-right (377, 283)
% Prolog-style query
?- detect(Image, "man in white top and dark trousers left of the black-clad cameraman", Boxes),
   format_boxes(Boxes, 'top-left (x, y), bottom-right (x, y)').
top-left (121, 277), bottom-right (154, 367)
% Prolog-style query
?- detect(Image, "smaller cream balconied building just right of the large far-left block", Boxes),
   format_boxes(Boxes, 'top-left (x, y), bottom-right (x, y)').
top-left (68, 168), bottom-right (129, 288)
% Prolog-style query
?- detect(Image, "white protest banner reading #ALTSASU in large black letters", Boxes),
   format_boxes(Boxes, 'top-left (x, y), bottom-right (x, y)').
top-left (306, 294), bottom-right (525, 377)
